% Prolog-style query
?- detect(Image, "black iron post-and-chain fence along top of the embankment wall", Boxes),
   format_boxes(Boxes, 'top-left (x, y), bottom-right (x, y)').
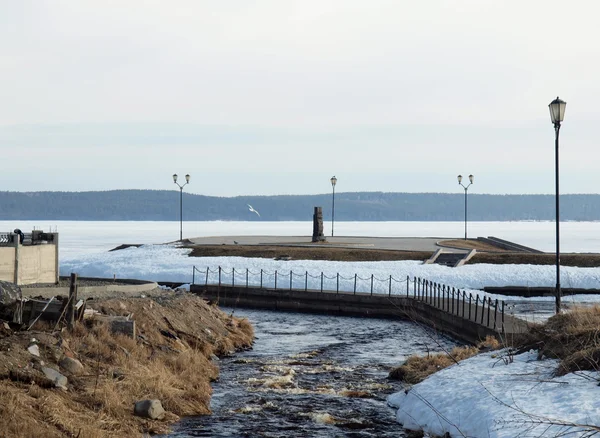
top-left (192, 266), bottom-right (505, 333)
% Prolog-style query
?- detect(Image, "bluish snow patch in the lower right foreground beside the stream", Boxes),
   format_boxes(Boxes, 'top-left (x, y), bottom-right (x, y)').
top-left (388, 351), bottom-right (600, 438)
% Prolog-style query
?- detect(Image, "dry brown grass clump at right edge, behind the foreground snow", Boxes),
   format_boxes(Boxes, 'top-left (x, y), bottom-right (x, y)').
top-left (521, 305), bottom-right (600, 375)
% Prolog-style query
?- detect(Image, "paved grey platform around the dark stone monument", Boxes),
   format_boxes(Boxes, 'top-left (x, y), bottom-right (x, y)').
top-left (189, 236), bottom-right (468, 253)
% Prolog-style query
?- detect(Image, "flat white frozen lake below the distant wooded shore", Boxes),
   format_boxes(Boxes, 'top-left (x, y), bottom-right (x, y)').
top-left (0, 220), bottom-right (600, 256)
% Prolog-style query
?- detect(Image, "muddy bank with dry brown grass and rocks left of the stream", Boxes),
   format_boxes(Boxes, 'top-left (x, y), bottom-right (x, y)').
top-left (0, 291), bottom-right (253, 437)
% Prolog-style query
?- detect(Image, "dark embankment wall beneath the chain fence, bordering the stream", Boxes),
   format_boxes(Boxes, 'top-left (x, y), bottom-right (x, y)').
top-left (190, 285), bottom-right (498, 344)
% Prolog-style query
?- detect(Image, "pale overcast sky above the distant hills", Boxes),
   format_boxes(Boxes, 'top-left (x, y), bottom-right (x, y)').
top-left (0, 0), bottom-right (600, 196)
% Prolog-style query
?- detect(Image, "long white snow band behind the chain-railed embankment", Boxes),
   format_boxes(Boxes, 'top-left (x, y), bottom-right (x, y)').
top-left (60, 245), bottom-right (600, 303)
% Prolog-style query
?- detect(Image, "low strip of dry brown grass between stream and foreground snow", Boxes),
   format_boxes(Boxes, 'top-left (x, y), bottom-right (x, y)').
top-left (389, 336), bottom-right (500, 384)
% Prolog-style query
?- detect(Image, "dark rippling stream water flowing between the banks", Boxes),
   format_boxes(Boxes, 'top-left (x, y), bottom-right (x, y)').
top-left (162, 308), bottom-right (456, 438)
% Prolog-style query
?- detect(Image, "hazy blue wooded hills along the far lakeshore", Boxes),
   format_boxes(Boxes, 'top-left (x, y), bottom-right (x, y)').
top-left (0, 190), bottom-right (600, 221)
